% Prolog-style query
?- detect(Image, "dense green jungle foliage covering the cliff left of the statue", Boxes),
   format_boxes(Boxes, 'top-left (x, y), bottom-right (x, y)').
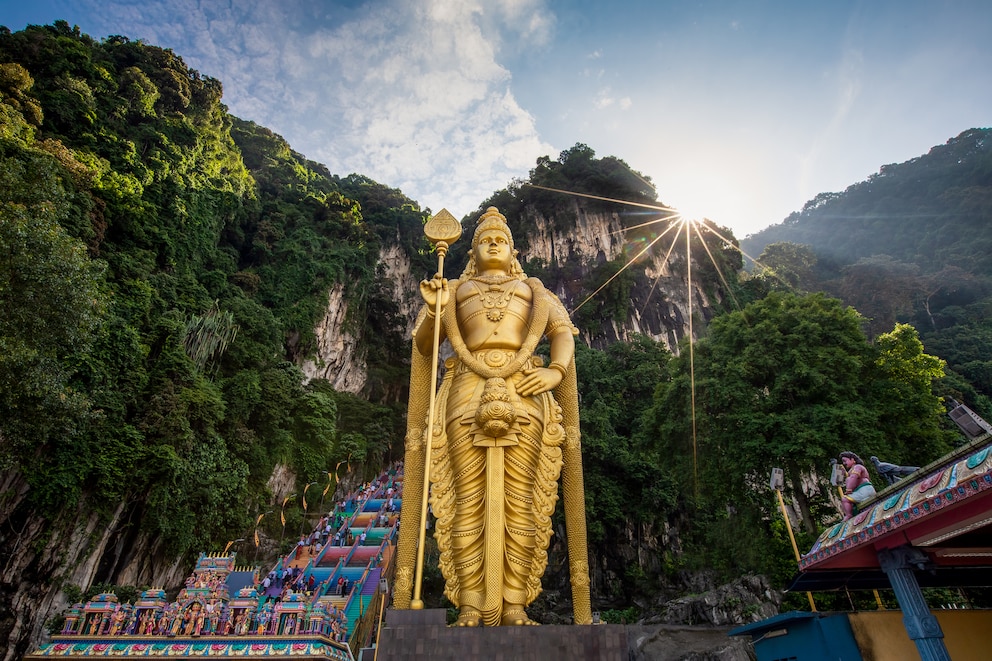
top-left (0, 22), bottom-right (430, 554)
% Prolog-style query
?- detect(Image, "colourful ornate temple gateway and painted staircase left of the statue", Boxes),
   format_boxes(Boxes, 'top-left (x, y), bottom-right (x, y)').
top-left (25, 466), bottom-right (402, 661)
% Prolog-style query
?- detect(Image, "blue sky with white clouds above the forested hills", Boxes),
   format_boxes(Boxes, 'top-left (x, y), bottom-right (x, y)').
top-left (0, 0), bottom-right (992, 237)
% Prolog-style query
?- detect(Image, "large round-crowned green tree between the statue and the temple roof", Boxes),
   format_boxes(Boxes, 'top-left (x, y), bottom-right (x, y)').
top-left (658, 292), bottom-right (860, 531)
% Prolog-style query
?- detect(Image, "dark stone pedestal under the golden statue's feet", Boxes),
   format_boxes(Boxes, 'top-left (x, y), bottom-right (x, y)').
top-left (378, 609), bottom-right (630, 661)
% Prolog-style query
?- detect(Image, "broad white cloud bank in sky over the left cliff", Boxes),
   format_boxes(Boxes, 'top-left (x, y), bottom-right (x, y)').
top-left (75, 0), bottom-right (554, 215)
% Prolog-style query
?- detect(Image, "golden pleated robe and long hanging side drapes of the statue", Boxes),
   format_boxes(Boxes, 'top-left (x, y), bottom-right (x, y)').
top-left (395, 278), bottom-right (591, 626)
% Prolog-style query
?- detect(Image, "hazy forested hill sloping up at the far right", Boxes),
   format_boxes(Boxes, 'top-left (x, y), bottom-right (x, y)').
top-left (741, 128), bottom-right (992, 419)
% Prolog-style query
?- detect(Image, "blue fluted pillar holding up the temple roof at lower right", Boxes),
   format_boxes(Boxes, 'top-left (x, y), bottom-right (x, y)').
top-left (878, 546), bottom-right (951, 661)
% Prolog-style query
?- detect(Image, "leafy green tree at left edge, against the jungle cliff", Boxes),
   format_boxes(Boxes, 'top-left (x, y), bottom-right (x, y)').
top-left (0, 141), bottom-right (105, 470)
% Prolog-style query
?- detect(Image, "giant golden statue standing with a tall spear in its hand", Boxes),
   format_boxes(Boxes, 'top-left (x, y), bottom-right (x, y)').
top-left (394, 207), bottom-right (592, 626)
